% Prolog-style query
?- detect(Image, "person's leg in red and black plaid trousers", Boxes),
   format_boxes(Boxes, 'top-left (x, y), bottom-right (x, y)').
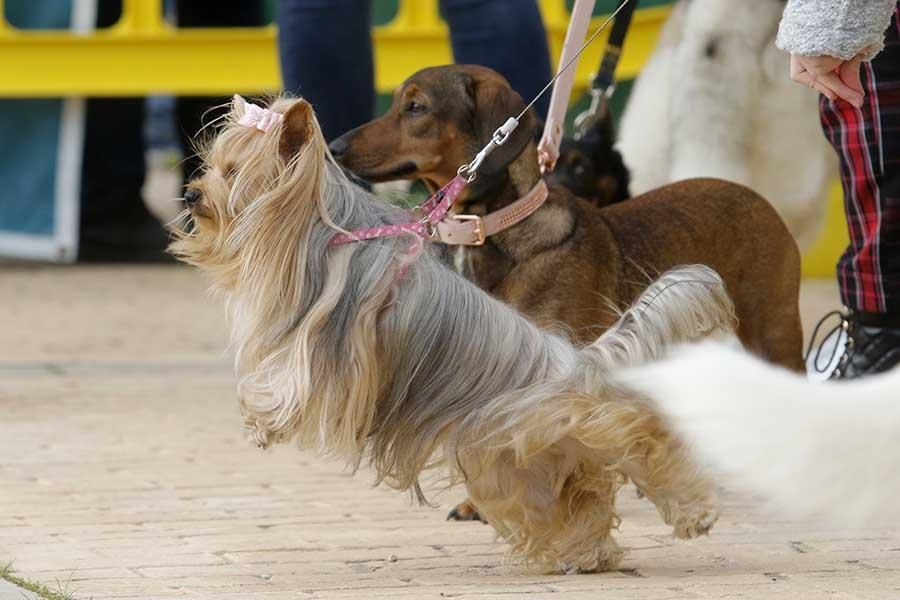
top-left (820, 3), bottom-right (900, 375)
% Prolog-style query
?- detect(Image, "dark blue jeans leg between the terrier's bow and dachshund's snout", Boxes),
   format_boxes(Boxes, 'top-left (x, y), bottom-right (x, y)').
top-left (276, 0), bottom-right (375, 141)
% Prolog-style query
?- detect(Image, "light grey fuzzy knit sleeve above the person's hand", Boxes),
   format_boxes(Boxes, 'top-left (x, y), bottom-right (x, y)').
top-left (776, 0), bottom-right (898, 60)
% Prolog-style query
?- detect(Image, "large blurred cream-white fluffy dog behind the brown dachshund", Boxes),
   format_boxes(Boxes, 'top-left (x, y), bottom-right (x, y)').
top-left (619, 0), bottom-right (836, 249)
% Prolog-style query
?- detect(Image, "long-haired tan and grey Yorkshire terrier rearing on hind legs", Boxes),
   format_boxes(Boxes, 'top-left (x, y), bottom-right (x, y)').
top-left (171, 97), bottom-right (733, 572)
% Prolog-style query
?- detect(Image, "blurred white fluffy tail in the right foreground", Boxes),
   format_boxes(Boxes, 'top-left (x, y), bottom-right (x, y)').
top-left (617, 342), bottom-right (900, 525)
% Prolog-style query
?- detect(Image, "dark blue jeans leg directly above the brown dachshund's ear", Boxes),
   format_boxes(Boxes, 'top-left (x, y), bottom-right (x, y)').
top-left (441, 0), bottom-right (552, 120)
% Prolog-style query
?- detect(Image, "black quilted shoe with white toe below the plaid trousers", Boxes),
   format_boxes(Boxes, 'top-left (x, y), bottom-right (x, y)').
top-left (806, 310), bottom-right (900, 380)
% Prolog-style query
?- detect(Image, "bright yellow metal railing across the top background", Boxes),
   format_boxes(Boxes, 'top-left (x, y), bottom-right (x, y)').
top-left (0, 0), bottom-right (668, 97)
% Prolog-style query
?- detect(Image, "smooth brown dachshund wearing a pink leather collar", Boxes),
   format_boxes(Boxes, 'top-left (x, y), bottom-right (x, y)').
top-left (331, 65), bottom-right (803, 371)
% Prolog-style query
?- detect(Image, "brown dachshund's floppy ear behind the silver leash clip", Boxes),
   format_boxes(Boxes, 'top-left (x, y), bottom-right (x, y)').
top-left (473, 75), bottom-right (537, 175)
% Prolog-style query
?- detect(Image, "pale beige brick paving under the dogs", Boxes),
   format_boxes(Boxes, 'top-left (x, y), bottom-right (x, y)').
top-left (0, 267), bottom-right (900, 600)
